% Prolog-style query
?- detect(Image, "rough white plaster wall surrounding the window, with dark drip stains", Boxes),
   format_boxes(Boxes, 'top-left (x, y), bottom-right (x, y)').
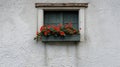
top-left (0, 0), bottom-right (120, 67)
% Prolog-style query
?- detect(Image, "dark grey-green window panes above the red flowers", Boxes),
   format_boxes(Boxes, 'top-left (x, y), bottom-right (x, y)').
top-left (44, 11), bottom-right (79, 29)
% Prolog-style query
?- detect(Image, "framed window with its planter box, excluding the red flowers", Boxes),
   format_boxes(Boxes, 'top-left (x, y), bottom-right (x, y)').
top-left (35, 3), bottom-right (88, 41)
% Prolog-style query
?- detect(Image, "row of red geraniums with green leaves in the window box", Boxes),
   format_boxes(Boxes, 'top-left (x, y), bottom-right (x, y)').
top-left (36, 22), bottom-right (79, 36)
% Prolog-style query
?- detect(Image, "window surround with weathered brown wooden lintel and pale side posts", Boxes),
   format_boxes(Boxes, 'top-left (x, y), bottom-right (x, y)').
top-left (35, 3), bottom-right (88, 41)
